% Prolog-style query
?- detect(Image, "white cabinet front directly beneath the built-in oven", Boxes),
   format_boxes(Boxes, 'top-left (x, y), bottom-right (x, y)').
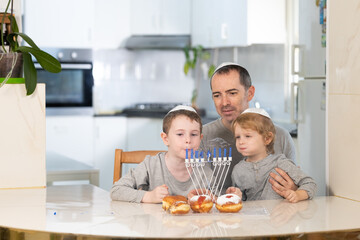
top-left (46, 115), bottom-right (94, 166)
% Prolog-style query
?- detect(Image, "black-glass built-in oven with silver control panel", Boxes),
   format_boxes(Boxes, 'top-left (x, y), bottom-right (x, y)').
top-left (35, 49), bottom-right (94, 107)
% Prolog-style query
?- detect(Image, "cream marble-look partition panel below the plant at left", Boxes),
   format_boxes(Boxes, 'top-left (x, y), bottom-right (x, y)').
top-left (0, 83), bottom-right (46, 189)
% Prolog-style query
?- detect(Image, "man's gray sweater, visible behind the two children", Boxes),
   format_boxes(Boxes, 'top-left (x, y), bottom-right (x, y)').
top-left (200, 118), bottom-right (295, 190)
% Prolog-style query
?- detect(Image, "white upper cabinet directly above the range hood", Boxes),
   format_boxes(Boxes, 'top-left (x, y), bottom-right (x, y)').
top-left (130, 0), bottom-right (191, 35)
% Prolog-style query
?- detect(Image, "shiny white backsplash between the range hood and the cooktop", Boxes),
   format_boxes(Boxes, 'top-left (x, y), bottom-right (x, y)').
top-left (94, 49), bottom-right (194, 113)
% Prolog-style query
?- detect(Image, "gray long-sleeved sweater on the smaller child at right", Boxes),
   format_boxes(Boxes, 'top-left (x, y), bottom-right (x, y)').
top-left (231, 154), bottom-right (316, 200)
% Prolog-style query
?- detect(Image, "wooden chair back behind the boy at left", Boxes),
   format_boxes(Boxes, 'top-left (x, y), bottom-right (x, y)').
top-left (113, 149), bottom-right (165, 183)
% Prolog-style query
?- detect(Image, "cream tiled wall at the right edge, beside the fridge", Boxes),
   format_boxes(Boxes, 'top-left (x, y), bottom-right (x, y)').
top-left (326, 0), bottom-right (360, 201)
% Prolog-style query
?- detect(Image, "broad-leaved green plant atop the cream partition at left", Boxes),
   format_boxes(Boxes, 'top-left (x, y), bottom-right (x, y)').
top-left (0, 0), bottom-right (61, 95)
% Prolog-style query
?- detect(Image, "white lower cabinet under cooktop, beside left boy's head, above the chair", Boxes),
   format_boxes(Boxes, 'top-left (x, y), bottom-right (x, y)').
top-left (126, 117), bottom-right (167, 151)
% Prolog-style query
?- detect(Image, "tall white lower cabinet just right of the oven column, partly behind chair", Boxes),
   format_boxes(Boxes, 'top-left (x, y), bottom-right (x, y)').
top-left (94, 117), bottom-right (127, 190)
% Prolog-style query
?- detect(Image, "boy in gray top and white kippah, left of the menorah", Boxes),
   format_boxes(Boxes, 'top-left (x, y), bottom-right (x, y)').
top-left (110, 105), bottom-right (211, 203)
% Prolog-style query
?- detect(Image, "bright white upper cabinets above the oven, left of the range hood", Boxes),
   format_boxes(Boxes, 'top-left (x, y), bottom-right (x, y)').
top-left (24, 0), bottom-right (130, 49)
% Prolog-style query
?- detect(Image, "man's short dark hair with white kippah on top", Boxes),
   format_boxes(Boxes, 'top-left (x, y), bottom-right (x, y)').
top-left (210, 62), bottom-right (252, 91)
